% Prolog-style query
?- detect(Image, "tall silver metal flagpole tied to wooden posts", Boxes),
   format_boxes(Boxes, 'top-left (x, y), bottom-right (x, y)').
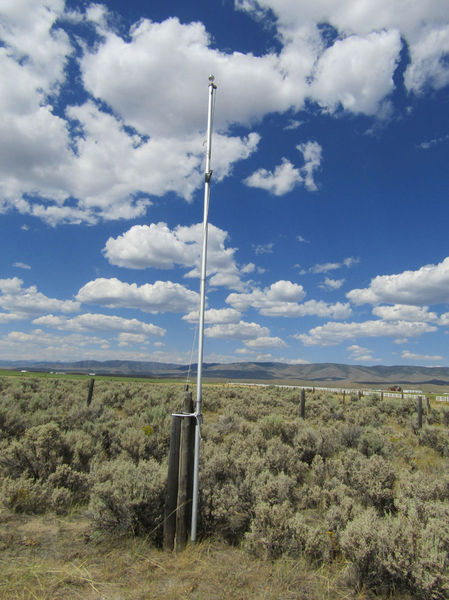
top-left (190, 75), bottom-right (217, 544)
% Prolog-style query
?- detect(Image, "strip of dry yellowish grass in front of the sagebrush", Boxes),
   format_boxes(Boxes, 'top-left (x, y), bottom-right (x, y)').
top-left (0, 511), bottom-right (409, 600)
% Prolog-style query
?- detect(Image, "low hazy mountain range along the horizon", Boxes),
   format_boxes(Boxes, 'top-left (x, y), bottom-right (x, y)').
top-left (0, 360), bottom-right (449, 386)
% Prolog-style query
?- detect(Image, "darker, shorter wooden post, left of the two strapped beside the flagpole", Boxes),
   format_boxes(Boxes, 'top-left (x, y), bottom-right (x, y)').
top-left (163, 416), bottom-right (182, 551)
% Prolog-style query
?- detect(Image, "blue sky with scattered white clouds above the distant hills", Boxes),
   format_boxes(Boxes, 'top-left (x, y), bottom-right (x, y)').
top-left (0, 0), bottom-right (449, 366)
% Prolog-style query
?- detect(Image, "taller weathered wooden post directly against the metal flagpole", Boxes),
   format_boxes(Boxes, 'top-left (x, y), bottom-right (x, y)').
top-left (175, 392), bottom-right (195, 551)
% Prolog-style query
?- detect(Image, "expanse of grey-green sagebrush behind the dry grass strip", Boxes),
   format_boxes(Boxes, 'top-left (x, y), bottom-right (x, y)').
top-left (0, 377), bottom-right (449, 600)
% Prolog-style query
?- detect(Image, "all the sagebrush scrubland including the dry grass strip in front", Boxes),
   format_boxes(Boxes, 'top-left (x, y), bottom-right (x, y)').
top-left (0, 377), bottom-right (449, 600)
